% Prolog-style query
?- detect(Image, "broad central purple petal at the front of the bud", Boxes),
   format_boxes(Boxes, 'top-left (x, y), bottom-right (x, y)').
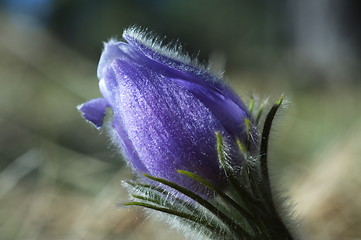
top-left (105, 60), bottom-right (225, 192)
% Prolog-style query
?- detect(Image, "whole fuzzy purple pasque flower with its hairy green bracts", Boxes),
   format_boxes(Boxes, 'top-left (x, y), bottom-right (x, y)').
top-left (78, 28), bottom-right (294, 240)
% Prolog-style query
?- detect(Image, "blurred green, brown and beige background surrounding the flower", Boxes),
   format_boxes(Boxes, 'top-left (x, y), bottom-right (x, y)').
top-left (0, 0), bottom-right (361, 240)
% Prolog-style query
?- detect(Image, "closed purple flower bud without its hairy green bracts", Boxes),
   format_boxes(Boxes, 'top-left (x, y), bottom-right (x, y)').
top-left (79, 28), bottom-right (251, 194)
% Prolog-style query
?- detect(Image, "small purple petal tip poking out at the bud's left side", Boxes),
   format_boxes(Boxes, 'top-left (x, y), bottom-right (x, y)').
top-left (78, 98), bottom-right (108, 128)
